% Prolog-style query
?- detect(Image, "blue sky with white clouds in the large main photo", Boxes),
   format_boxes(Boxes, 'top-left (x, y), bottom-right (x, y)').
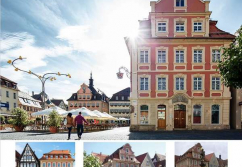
top-left (1, 0), bottom-right (242, 100)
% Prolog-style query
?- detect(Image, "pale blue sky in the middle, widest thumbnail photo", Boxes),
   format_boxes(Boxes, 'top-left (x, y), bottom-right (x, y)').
top-left (84, 142), bottom-right (166, 158)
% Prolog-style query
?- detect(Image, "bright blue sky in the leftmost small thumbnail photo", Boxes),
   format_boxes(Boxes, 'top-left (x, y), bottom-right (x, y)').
top-left (15, 142), bottom-right (76, 159)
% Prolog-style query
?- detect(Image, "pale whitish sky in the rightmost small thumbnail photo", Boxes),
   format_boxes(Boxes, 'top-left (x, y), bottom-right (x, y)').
top-left (175, 142), bottom-right (228, 159)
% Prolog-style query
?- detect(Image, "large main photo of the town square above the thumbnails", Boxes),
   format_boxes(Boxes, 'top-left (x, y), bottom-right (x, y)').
top-left (0, 0), bottom-right (242, 140)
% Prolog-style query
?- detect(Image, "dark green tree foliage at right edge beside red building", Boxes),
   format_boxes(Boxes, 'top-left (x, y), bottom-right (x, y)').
top-left (218, 26), bottom-right (242, 89)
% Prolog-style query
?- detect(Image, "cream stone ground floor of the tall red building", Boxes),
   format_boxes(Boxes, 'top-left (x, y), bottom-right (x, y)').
top-left (130, 94), bottom-right (230, 131)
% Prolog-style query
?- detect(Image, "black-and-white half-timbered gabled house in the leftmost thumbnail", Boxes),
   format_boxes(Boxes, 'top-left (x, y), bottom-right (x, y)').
top-left (18, 143), bottom-right (40, 167)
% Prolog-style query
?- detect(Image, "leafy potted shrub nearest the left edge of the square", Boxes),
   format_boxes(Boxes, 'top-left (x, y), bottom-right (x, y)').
top-left (9, 108), bottom-right (29, 132)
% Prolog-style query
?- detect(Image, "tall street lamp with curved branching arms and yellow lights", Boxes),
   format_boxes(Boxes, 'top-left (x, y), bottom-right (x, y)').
top-left (8, 56), bottom-right (71, 110)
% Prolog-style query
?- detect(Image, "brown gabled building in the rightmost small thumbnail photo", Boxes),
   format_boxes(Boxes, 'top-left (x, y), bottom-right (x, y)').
top-left (175, 143), bottom-right (209, 167)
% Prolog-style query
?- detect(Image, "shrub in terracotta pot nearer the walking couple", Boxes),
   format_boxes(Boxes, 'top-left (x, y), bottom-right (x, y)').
top-left (47, 110), bottom-right (61, 133)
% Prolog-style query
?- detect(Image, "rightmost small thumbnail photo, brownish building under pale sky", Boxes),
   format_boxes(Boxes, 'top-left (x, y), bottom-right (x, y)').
top-left (175, 142), bottom-right (228, 167)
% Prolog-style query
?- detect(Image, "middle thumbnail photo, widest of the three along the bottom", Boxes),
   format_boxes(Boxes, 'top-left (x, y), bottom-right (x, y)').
top-left (83, 142), bottom-right (166, 167)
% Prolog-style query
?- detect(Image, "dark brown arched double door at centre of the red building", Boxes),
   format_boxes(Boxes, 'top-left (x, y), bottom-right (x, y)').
top-left (174, 104), bottom-right (186, 128)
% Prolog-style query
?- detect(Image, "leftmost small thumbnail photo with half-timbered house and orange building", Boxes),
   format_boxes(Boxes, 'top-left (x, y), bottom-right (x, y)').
top-left (15, 142), bottom-right (75, 167)
